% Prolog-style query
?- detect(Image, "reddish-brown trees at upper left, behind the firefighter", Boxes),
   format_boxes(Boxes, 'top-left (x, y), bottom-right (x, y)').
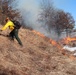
top-left (0, 0), bottom-right (21, 21)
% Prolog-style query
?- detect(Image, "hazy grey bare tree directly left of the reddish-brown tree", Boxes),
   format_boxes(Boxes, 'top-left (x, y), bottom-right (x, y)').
top-left (39, 0), bottom-right (56, 31)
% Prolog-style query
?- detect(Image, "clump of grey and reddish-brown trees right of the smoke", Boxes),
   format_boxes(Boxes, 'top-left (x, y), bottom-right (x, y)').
top-left (39, 0), bottom-right (75, 37)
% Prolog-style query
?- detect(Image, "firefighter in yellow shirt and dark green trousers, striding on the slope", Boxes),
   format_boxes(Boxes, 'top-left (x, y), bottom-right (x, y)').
top-left (1, 18), bottom-right (23, 46)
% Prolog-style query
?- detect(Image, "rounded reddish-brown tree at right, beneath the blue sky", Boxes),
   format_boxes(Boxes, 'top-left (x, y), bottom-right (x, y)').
top-left (55, 10), bottom-right (75, 36)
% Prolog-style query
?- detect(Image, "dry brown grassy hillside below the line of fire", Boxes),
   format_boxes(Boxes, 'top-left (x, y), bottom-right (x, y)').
top-left (0, 29), bottom-right (76, 75)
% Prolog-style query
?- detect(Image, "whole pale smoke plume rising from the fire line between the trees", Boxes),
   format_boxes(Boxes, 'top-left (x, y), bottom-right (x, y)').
top-left (18, 0), bottom-right (58, 39)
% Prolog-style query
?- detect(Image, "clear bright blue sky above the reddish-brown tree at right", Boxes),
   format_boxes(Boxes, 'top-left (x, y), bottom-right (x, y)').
top-left (53, 0), bottom-right (76, 20)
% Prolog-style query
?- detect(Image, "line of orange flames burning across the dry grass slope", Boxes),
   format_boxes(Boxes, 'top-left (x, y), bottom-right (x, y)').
top-left (32, 30), bottom-right (76, 60)
